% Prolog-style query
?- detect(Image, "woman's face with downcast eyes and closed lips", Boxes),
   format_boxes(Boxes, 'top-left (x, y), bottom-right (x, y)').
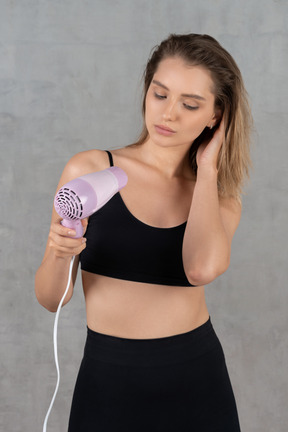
top-left (145, 57), bottom-right (219, 147)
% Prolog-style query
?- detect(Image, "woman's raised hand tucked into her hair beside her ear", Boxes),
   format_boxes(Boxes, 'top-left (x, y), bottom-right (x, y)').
top-left (196, 116), bottom-right (225, 171)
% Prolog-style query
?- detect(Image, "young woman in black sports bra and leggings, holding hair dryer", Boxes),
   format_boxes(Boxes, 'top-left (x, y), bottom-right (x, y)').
top-left (35, 34), bottom-right (251, 432)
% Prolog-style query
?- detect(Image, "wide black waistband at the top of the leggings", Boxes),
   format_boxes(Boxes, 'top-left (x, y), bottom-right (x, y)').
top-left (85, 317), bottom-right (222, 367)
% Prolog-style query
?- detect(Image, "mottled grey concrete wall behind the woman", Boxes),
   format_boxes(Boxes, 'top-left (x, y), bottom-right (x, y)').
top-left (0, 0), bottom-right (288, 432)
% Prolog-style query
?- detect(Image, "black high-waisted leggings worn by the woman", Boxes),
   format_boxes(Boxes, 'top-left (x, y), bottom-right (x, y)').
top-left (68, 318), bottom-right (240, 432)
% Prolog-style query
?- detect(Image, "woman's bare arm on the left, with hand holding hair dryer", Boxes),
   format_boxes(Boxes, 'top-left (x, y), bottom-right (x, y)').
top-left (35, 154), bottom-right (89, 312)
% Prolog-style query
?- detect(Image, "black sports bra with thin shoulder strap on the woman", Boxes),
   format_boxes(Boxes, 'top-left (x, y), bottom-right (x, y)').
top-left (80, 151), bottom-right (194, 286)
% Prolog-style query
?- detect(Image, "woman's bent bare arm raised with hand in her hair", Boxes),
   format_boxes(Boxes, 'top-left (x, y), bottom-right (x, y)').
top-left (183, 119), bottom-right (241, 286)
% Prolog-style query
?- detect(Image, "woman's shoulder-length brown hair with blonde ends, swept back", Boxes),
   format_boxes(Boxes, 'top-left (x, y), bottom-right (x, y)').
top-left (135, 33), bottom-right (253, 198)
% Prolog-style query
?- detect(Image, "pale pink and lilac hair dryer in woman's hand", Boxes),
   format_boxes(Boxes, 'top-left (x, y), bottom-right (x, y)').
top-left (54, 166), bottom-right (128, 238)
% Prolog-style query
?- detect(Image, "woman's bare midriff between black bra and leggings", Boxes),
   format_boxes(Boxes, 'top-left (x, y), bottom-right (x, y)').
top-left (82, 271), bottom-right (209, 339)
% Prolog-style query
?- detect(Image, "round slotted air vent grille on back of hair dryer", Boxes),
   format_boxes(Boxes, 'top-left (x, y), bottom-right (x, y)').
top-left (55, 187), bottom-right (83, 220)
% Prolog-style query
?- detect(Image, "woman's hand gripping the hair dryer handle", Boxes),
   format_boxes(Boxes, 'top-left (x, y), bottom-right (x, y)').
top-left (48, 218), bottom-right (88, 258)
